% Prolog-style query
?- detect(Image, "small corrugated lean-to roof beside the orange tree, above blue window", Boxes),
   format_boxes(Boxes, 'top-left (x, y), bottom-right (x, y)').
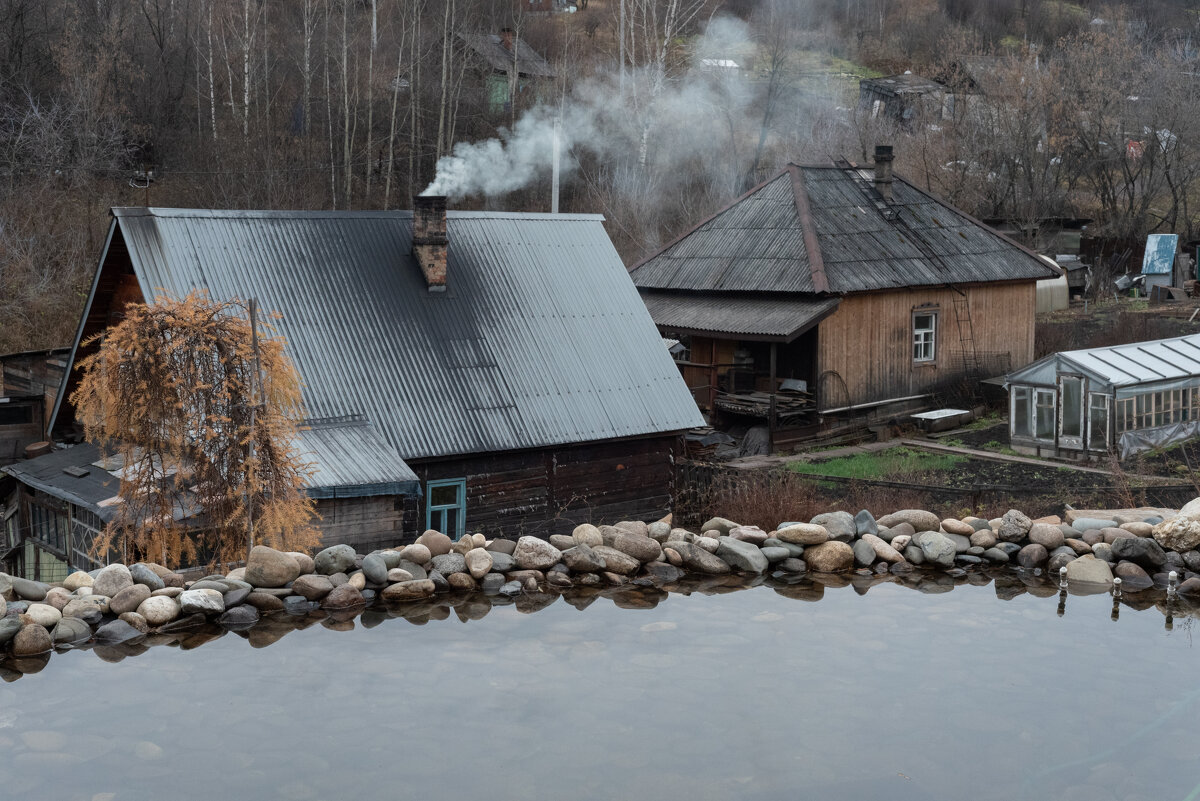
top-left (298, 417), bottom-right (419, 498)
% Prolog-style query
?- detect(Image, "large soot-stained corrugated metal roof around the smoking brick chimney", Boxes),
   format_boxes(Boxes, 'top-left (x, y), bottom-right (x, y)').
top-left (114, 209), bottom-right (703, 460)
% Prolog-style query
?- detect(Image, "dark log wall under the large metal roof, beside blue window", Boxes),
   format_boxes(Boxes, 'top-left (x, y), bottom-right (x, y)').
top-left (406, 436), bottom-right (677, 537)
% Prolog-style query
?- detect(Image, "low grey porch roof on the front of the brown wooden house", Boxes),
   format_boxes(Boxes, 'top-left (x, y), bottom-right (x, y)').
top-left (642, 291), bottom-right (841, 342)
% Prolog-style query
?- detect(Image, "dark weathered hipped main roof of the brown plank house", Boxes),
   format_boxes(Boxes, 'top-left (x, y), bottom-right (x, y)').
top-left (631, 164), bottom-right (1058, 294)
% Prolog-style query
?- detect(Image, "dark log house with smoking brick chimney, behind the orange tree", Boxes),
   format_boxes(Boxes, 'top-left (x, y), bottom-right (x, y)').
top-left (6, 198), bottom-right (703, 572)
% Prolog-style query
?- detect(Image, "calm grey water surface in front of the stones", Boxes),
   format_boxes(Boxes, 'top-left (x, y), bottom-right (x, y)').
top-left (0, 575), bottom-right (1200, 801)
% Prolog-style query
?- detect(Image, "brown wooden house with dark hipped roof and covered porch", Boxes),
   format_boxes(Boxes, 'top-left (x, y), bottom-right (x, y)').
top-left (630, 146), bottom-right (1058, 443)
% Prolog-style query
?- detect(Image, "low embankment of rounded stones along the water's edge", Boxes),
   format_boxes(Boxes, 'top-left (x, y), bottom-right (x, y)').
top-left (0, 499), bottom-right (1200, 657)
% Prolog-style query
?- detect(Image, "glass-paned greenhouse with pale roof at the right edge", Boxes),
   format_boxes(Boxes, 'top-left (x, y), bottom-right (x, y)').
top-left (1004, 333), bottom-right (1200, 459)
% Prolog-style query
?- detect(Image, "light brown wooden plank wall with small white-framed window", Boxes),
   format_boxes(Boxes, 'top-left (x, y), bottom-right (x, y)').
top-left (817, 282), bottom-right (1036, 409)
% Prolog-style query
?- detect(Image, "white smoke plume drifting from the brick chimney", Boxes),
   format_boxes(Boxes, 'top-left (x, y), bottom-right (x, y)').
top-left (421, 18), bottom-right (754, 200)
